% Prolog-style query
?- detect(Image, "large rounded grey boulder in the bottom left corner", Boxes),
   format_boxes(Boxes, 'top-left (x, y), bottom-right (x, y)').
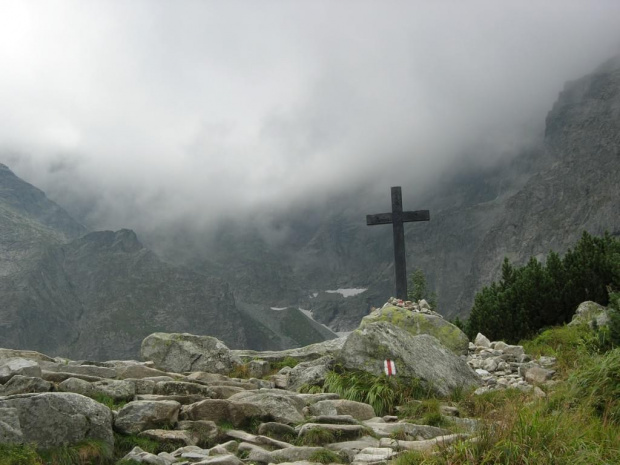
top-left (0, 392), bottom-right (114, 449)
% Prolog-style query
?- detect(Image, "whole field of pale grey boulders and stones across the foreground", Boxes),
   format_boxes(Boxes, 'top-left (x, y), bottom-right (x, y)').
top-left (0, 301), bottom-right (553, 465)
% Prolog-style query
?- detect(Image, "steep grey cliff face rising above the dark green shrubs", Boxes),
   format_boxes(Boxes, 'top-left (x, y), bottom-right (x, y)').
top-left (460, 58), bottom-right (620, 311)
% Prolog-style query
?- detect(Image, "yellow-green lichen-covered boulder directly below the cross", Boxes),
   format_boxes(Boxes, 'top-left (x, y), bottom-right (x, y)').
top-left (360, 305), bottom-right (469, 355)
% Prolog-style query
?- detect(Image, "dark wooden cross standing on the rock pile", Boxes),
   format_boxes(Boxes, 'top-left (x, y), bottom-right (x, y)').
top-left (366, 186), bottom-right (431, 300)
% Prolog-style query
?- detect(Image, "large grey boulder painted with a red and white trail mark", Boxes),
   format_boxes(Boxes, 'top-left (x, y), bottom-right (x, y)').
top-left (340, 322), bottom-right (480, 395)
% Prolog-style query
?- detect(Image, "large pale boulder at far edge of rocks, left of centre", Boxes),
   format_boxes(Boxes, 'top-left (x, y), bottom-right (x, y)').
top-left (141, 333), bottom-right (241, 374)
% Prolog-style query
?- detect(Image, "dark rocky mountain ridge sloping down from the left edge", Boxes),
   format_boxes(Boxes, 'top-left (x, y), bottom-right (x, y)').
top-left (0, 165), bottom-right (335, 360)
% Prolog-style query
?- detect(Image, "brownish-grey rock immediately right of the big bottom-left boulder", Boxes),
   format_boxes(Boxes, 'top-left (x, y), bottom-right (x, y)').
top-left (114, 400), bottom-right (181, 434)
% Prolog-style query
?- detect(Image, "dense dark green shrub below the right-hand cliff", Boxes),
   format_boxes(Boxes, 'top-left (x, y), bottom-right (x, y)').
top-left (465, 232), bottom-right (620, 343)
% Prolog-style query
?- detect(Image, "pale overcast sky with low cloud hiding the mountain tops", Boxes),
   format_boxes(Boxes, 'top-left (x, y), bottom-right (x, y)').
top-left (0, 0), bottom-right (620, 236)
